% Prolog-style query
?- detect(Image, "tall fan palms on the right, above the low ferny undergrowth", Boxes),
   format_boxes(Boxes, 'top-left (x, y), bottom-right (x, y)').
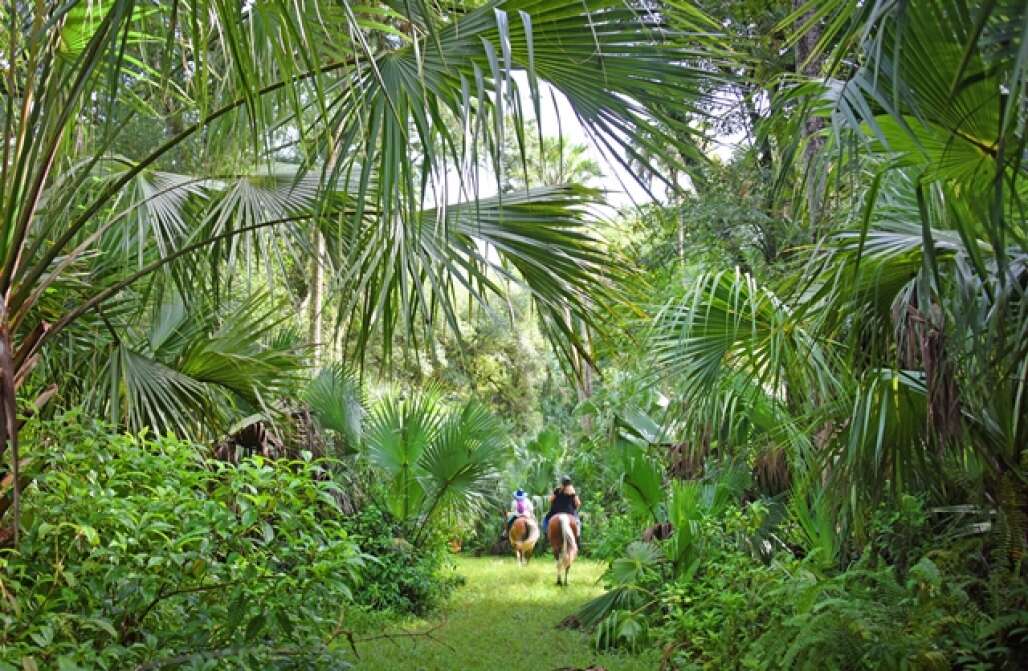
top-left (656, 0), bottom-right (1028, 554)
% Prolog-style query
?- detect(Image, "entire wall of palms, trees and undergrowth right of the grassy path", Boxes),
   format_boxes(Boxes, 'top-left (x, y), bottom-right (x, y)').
top-left (542, 0), bottom-right (1028, 669)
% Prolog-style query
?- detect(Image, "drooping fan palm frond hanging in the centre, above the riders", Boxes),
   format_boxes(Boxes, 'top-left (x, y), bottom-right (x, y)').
top-left (329, 186), bottom-right (616, 371)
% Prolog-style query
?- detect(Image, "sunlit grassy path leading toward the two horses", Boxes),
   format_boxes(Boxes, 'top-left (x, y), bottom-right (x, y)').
top-left (357, 557), bottom-right (658, 671)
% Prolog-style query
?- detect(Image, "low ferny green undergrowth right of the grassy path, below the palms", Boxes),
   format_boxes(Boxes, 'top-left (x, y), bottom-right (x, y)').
top-left (579, 500), bottom-right (1028, 671)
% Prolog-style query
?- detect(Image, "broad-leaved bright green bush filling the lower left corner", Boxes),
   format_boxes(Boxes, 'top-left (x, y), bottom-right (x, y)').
top-left (0, 415), bottom-right (365, 671)
